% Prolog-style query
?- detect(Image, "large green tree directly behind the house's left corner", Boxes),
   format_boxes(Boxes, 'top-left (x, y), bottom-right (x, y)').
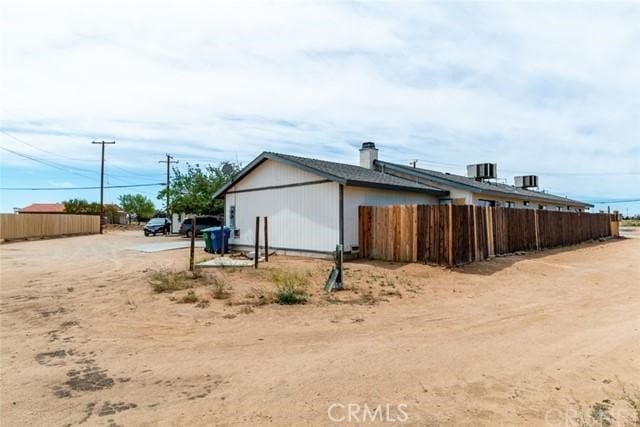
top-left (158, 162), bottom-right (240, 215)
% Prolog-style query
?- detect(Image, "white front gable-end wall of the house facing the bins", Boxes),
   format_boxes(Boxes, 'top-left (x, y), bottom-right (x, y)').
top-left (225, 160), bottom-right (339, 252)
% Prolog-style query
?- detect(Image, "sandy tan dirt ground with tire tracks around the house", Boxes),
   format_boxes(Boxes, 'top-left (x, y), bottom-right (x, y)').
top-left (0, 231), bottom-right (640, 426)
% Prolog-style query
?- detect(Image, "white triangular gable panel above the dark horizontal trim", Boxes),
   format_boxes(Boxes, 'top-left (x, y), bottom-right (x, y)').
top-left (228, 160), bottom-right (323, 191)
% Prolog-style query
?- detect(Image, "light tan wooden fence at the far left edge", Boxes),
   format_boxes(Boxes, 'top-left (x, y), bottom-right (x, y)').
top-left (0, 214), bottom-right (100, 240)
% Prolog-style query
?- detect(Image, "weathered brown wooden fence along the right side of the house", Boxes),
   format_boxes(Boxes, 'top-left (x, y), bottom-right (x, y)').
top-left (359, 205), bottom-right (614, 266)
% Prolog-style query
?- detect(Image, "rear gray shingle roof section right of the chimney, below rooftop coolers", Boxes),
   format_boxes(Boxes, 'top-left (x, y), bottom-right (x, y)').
top-left (376, 160), bottom-right (593, 207)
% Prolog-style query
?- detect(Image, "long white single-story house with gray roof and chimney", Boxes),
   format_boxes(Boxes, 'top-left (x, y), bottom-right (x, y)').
top-left (214, 142), bottom-right (590, 255)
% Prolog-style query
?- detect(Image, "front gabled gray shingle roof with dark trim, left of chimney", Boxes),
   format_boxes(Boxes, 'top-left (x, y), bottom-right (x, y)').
top-left (214, 152), bottom-right (449, 198)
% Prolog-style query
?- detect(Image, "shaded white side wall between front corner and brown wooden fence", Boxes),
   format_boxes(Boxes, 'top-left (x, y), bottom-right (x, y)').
top-left (344, 187), bottom-right (438, 251)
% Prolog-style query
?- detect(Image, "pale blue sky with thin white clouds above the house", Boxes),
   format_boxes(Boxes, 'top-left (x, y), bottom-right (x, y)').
top-left (0, 0), bottom-right (640, 213)
